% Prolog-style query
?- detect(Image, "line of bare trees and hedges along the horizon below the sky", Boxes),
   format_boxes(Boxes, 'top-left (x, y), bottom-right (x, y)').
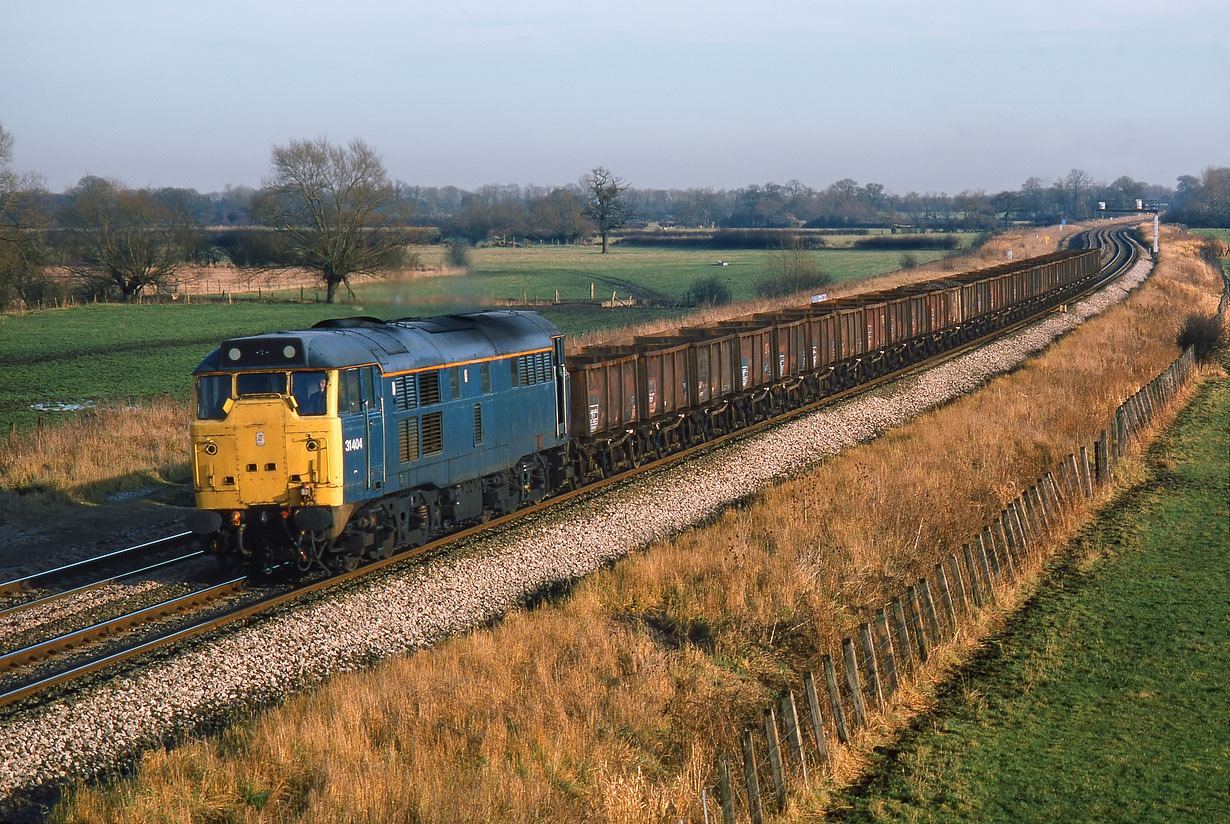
top-left (0, 125), bottom-right (1230, 313)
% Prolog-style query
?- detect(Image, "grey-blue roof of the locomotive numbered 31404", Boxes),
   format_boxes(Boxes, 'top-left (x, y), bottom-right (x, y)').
top-left (193, 310), bottom-right (560, 374)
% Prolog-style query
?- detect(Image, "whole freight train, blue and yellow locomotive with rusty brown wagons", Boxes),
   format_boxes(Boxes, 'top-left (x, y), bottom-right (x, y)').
top-left (188, 250), bottom-right (1100, 573)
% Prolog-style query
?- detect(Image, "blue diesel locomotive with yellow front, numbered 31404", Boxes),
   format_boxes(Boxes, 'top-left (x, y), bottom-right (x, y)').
top-left (192, 311), bottom-right (568, 571)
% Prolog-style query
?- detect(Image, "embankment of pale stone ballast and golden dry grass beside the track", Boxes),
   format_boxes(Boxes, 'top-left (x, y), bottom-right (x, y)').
top-left (7, 227), bottom-right (1208, 820)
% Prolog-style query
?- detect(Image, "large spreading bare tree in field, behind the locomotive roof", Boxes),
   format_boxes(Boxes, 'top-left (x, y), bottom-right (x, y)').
top-left (252, 138), bottom-right (406, 303)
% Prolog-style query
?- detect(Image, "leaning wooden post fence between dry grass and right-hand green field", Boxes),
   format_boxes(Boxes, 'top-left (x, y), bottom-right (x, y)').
top-left (701, 339), bottom-right (1200, 824)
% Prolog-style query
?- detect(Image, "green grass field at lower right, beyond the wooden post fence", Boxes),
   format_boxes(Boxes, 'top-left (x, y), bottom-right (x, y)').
top-left (830, 361), bottom-right (1230, 824)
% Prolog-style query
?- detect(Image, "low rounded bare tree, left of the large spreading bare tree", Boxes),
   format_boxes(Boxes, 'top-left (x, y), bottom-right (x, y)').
top-left (59, 176), bottom-right (194, 300)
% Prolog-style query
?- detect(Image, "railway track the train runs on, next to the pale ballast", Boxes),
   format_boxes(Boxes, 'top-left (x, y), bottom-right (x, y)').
top-left (0, 228), bottom-right (1139, 706)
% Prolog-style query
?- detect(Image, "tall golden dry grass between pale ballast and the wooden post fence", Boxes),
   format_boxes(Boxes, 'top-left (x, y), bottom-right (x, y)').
top-left (43, 227), bottom-right (1220, 823)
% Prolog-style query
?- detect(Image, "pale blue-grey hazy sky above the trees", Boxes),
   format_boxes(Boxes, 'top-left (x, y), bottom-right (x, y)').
top-left (0, 0), bottom-right (1230, 194)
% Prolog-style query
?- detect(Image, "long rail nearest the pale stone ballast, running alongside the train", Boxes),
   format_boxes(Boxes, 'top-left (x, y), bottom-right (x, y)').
top-left (0, 231), bottom-right (1135, 707)
